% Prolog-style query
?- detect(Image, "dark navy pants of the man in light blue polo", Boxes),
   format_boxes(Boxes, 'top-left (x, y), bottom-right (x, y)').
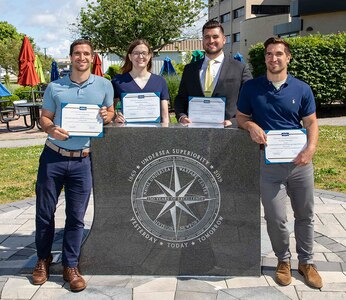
top-left (35, 146), bottom-right (92, 267)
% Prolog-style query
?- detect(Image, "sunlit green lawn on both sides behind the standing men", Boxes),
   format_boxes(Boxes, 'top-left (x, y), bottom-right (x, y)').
top-left (0, 126), bottom-right (346, 203)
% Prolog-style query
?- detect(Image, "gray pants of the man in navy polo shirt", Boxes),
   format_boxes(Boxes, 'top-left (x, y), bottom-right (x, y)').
top-left (260, 155), bottom-right (314, 264)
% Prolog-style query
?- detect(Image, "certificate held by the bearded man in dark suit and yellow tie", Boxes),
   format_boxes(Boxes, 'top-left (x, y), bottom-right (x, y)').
top-left (188, 97), bottom-right (226, 124)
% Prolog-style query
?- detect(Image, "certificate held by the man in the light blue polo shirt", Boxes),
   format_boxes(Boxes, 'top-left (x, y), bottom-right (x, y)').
top-left (61, 103), bottom-right (103, 137)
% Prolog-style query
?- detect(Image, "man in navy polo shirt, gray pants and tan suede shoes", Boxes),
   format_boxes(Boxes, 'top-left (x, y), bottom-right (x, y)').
top-left (236, 38), bottom-right (322, 288)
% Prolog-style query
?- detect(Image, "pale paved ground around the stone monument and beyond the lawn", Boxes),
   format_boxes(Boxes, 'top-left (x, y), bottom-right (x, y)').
top-left (0, 118), bottom-right (346, 300)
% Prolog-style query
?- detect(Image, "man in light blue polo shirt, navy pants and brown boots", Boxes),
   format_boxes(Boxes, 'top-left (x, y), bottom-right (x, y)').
top-left (33, 39), bottom-right (114, 292)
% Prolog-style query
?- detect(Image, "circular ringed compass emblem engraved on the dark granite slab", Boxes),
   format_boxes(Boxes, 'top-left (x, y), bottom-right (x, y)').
top-left (131, 155), bottom-right (220, 242)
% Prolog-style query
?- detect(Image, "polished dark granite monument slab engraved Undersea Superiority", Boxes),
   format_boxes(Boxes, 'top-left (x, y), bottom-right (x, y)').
top-left (80, 125), bottom-right (261, 276)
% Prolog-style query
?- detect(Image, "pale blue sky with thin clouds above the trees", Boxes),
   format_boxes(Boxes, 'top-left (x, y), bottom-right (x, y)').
top-left (0, 0), bottom-right (206, 59)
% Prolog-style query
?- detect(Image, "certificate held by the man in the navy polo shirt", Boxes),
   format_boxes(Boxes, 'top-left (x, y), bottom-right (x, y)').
top-left (264, 129), bottom-right (307, 164)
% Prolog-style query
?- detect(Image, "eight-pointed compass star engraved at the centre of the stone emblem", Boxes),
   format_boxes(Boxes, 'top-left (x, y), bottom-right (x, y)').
top-left (137, 160), bottom-right (216, 236)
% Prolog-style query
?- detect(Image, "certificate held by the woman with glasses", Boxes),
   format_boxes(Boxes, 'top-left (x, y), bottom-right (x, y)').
top-left (121, 93), bottom-right (161, 123)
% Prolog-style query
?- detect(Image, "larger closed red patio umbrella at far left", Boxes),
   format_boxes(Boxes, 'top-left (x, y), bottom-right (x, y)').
top-left (17, 36), bottom-right (40, 99)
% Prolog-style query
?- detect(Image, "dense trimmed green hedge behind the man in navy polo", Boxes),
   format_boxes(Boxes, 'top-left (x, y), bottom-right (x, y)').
top-left (249, 33), bottom-right (346, 106)
